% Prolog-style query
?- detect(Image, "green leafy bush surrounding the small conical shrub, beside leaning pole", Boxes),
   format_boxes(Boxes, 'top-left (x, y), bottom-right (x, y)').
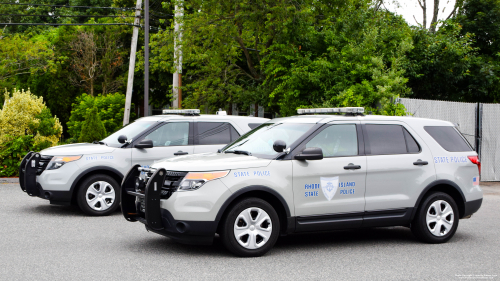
top-left (67, 93), bottom-right (135, 139)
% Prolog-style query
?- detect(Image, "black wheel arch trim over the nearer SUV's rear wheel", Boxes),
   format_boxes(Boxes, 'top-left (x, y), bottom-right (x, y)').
top-left (411, 180), bottom-right (466, 220)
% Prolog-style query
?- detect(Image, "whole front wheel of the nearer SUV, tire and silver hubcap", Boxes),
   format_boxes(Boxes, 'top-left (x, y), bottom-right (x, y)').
top-left (220, 198), bottom-right (280, 257)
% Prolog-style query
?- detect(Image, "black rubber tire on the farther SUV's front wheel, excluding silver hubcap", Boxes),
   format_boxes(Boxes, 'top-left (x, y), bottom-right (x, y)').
top-left (76, 174), bottom-right (120, 216)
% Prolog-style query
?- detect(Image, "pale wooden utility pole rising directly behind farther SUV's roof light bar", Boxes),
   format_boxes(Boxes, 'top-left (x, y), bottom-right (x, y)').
top-left (172, 0), bottom-right (184, 108)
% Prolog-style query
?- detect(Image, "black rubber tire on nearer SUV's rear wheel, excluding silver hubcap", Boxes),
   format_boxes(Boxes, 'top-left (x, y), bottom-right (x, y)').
top-left (411, 192), bottom-right (460, 244)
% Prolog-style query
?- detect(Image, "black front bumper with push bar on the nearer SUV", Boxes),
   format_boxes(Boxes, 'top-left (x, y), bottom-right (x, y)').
top-left (121, 165), bottom-right (217, 245)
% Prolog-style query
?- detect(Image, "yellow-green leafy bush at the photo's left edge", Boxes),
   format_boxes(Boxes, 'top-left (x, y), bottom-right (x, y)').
top-left (0, 89), bottom-right (62, 146)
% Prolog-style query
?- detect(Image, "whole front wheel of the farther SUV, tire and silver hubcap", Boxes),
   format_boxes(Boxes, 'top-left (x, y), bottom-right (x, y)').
top-left (77, 174), bottom-right (120, 216)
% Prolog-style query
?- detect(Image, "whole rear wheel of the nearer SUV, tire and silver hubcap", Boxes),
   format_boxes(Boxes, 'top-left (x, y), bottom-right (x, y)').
top-left (411, 192), bottom-right (459, 244)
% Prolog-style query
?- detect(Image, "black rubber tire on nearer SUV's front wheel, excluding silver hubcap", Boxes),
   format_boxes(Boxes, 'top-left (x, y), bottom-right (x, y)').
top-left (220, 197), bottom-right (280, 257)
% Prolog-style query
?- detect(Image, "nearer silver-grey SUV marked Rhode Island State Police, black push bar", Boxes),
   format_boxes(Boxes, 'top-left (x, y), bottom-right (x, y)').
top-left (121, 108), bottom-right (483, 256)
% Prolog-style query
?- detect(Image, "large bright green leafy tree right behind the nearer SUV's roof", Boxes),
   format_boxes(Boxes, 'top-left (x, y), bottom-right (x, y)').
top-left (264, 2), bottom-right (412, 115)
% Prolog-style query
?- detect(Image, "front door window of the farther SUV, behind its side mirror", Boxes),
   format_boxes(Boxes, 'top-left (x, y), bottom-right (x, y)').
top-left (144, 122), bottom-right (189, 147)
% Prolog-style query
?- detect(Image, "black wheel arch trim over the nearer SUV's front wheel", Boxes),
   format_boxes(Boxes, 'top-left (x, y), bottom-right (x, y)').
top-left (215, 185), bottom-right (295, 234)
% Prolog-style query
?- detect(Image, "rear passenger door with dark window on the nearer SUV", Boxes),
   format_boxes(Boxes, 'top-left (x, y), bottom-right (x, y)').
top-left (362, 121), bottom-right (436, 212)
